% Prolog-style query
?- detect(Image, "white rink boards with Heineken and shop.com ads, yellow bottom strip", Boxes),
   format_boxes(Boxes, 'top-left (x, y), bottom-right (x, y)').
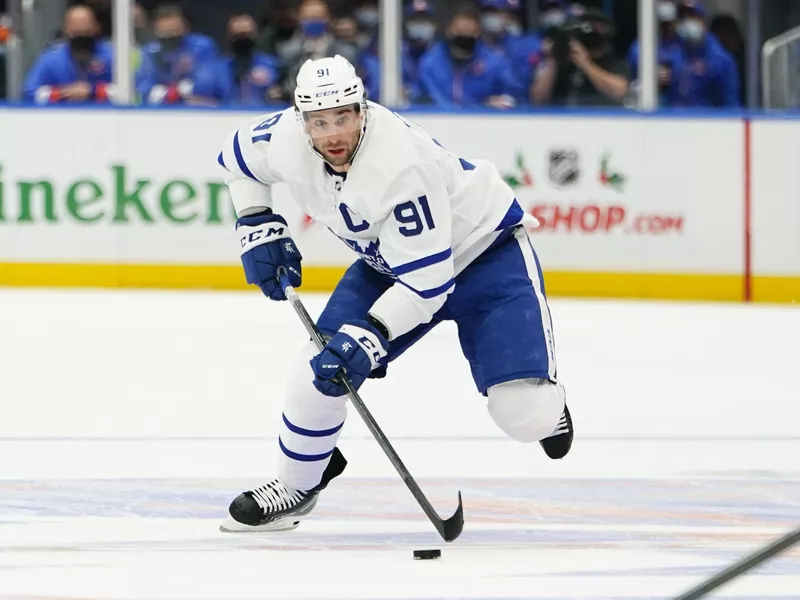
top-left (0, 110), bottom-right (800, 300)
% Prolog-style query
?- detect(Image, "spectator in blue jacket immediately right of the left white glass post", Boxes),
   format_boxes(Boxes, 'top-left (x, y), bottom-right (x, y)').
top-left (136, 5), bottom-right (218, 105)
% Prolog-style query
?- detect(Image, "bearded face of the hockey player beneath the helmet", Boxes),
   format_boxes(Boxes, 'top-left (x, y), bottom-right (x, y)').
top-left (306, 107), bottom-right (361, 167)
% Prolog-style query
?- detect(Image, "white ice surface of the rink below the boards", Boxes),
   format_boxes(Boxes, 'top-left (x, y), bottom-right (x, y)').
top-left (0, 290), bottom-right (800, 600)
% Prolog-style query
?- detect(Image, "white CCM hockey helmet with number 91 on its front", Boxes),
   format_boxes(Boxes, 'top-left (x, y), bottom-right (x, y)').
top-left (294, 54), bottom-right (367, 158)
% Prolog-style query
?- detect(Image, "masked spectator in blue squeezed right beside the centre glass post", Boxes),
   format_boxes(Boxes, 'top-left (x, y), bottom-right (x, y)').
top-left (403, 0), bottom-right (436, 104)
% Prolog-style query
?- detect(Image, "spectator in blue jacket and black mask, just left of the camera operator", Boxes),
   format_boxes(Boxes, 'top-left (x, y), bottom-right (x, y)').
top-left (419, 6), bottom-right (516, 109)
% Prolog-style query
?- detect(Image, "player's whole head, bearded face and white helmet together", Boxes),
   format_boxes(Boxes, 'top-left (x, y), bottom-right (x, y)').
top-left (294, 54), bottom-right (367, 167)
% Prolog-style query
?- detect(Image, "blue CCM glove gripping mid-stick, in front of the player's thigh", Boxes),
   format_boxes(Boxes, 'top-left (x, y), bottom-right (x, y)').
top-left (310, 321), bottom-right (389, 397)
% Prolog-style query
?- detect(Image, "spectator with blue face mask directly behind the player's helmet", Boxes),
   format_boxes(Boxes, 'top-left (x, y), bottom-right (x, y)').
top-left (283, 0), bottom-right (358, 99)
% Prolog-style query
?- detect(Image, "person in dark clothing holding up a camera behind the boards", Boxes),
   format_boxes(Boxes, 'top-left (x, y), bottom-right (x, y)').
top-left (530, 7), bottom-right (629, 106)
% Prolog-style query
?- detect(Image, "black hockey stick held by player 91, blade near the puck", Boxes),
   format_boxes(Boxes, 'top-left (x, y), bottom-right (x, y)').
top-left (278, 267), bottom-right (464, 542)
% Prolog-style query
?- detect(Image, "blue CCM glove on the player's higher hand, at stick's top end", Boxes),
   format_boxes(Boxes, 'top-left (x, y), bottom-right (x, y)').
top-left (236, 213), bottom-right (303, 300)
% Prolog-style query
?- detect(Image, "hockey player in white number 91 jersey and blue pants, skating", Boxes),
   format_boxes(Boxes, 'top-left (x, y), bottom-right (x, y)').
top-left (218, 56), bottom-right (573, 531)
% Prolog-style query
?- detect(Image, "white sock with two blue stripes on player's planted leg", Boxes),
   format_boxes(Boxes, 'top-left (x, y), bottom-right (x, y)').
top-left (278, 344), bottom-right (347, 491)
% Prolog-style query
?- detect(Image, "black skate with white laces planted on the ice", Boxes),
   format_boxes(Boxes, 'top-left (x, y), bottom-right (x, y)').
top-left (220, 448), bottom-right (347, 532)
